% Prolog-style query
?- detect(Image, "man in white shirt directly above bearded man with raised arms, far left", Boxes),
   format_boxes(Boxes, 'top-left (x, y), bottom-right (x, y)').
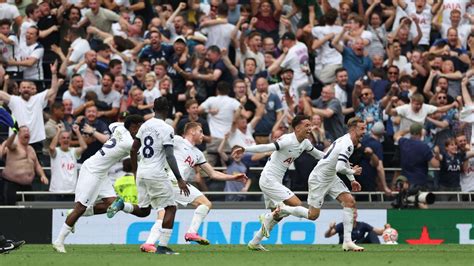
top-left (7, 26), bottom-right (44, 81)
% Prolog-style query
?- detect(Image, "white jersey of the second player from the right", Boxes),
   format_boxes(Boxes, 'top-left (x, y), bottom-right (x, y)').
top-left (262, 133), bottom-right (315, 182)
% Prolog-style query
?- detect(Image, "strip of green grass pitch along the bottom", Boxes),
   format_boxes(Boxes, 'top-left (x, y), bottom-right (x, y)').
top-left (0, 244), bottom-right (474, 266)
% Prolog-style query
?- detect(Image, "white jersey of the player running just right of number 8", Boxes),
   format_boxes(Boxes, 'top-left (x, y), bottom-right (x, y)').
top-left (166, 136), bottom-right (206, 182)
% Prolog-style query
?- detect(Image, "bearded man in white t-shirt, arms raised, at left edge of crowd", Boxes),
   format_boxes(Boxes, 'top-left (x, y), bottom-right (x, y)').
top-left (0, 64), bottom-right (62, 148)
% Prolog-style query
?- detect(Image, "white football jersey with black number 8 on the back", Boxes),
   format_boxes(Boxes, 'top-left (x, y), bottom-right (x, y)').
top-left (137, 118), bottom-right (174, 179)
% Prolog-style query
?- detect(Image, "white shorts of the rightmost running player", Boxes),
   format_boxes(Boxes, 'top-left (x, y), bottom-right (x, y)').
top-left (308, 176), bottom-right (350, 209)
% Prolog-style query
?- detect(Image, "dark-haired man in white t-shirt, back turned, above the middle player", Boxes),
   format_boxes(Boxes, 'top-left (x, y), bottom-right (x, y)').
top-left (199, 81), bottom-right (241, 165)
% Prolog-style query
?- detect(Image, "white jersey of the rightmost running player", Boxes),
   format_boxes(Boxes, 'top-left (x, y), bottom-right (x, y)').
top-left (309, 134), bottom-right (354, 181)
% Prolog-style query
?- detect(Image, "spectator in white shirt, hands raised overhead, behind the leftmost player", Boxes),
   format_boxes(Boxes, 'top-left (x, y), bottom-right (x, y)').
top-left (48, 124), bottom-right (87, 198)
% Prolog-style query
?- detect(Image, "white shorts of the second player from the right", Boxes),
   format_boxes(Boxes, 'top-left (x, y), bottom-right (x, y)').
top-left (258, 174), bottom-right (295, 209)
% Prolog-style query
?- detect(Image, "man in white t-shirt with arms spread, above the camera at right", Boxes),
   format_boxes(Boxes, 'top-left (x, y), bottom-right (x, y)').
top-left (385, 93), bottom-right (458, 131)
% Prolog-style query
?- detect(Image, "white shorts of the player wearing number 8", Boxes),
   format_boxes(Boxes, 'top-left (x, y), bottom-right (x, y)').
top-left (137, 178), bottom-right (176, 209)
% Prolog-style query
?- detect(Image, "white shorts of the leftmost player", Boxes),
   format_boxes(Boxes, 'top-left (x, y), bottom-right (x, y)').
top-left (74, 165), bottom-right (117, 207)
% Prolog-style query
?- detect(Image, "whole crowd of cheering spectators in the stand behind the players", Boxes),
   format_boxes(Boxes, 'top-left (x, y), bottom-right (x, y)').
top-left (0, 0), bottom-right (474, 205)
